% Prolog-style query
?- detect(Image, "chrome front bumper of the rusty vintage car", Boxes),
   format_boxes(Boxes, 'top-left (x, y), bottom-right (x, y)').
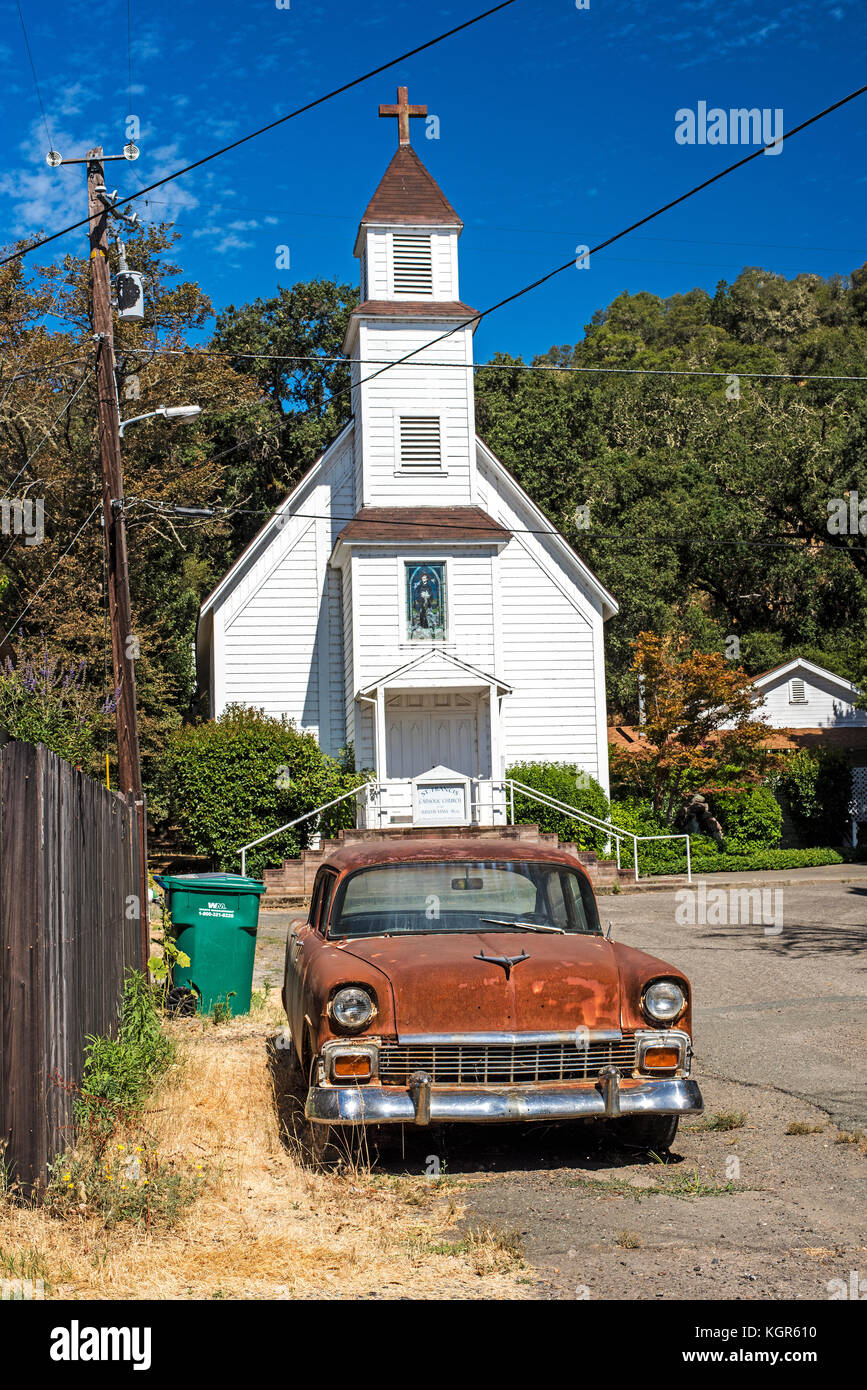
top-left (304, 1068), bottom-right (704, 1126)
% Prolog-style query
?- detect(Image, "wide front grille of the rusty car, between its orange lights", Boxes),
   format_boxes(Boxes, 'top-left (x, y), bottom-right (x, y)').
top-left (379, 1033), bottom-right (635, 1086)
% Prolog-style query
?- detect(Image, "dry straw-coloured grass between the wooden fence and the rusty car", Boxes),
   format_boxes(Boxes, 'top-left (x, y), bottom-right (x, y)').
top-left (0, 1006), bottom-right (528, 1298)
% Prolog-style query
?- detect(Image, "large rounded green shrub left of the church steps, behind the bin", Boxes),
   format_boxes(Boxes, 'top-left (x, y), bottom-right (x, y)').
top-left (160, 705), bottom-right (364, 874)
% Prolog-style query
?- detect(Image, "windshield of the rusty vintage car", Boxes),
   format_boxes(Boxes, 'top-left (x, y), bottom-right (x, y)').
top-left (328, 860), bottom-right (599, 938)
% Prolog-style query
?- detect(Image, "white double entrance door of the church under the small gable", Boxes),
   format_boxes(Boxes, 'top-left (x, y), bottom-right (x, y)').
top-left (385, 691), bottom-right (490, 778)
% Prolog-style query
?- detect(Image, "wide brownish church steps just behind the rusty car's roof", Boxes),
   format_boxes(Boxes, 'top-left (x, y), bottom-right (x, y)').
top-left (263, 824), bottom-right (632, 908)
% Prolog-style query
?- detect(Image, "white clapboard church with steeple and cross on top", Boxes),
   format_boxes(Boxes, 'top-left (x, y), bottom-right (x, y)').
top-left (197, 88), bottom-right (617, 826)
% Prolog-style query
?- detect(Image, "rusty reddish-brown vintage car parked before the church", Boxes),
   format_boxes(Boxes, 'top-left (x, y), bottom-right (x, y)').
top-left (283, 837), bottom-right (703, 1152)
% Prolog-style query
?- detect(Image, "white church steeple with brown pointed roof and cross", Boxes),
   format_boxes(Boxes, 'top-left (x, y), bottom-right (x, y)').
top-left (345, 96), bottom-right (475, 506)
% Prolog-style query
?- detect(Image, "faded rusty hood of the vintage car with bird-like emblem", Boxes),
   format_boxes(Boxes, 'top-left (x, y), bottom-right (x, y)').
top-left (333, 931), bottom-right (620, 1037)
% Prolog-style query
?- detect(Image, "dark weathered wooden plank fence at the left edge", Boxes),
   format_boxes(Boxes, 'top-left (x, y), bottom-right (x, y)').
top-left (0, 742), bottom-right (147, 1186)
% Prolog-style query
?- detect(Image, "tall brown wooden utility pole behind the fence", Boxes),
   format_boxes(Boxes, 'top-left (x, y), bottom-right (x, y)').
top-left (86, 146), bottom-right (142, 802)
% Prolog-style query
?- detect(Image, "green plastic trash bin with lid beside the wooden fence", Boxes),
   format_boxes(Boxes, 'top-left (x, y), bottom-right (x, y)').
top-left (154, 873), bottom-right (265, 1015)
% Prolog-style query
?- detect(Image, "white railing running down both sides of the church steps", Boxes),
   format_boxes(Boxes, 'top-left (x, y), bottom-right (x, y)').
top-left (238, 777), bottom-right (692, 883)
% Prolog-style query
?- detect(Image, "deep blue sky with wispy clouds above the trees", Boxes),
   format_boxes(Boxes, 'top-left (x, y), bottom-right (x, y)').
top-left (0, 0), bottom-right (867, 360)
